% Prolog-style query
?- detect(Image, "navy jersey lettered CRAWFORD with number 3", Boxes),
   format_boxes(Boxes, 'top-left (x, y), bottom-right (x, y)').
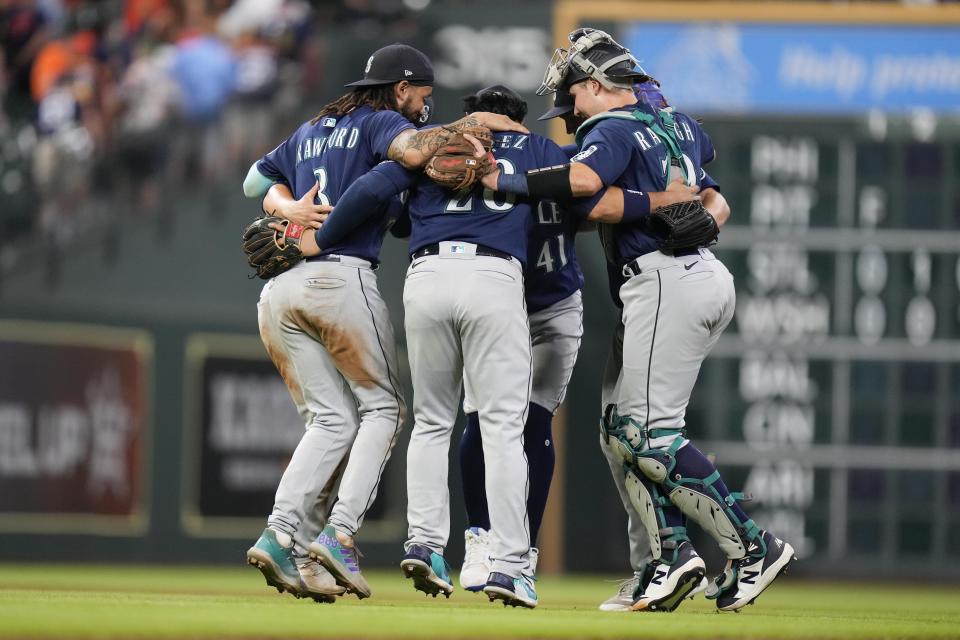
top-left (257, 106), bottom-right (413, 263)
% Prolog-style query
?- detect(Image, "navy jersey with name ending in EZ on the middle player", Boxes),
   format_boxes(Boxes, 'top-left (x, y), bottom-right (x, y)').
top-left (407, 132), bottom-right (567, 265)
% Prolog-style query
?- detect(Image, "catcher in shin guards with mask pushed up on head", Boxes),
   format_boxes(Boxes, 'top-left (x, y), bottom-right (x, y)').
top-left (484, 29), bottom-right (793, 611)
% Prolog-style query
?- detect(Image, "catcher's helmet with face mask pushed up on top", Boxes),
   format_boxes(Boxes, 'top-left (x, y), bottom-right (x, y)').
top-left (537, 29), bottom-right (649, 96)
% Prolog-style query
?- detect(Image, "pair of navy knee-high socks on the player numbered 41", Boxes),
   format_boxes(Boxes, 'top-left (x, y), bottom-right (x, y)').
top-left (460, 404), bottom-right (556, 546)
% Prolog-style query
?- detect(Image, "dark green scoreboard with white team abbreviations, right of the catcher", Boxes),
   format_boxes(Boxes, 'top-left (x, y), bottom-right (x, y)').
top-left (687, 113), bottom-right (960, 575)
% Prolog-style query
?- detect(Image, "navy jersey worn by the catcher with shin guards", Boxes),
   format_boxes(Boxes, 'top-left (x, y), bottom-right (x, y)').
top-left (573, 104), bottom-right (717, 265)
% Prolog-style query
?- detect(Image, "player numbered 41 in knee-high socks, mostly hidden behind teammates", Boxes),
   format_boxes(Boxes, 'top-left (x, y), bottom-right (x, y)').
top-left (460, 85), bottom-right (583, 591)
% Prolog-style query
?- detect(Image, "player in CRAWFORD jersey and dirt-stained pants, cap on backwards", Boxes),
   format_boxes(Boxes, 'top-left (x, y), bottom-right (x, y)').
top-left (244, 44), bottom-right (524, 600)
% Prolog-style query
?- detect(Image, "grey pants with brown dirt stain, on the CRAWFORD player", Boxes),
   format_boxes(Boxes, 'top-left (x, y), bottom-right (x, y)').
top-left (258, 256), bottom-right (406, 546)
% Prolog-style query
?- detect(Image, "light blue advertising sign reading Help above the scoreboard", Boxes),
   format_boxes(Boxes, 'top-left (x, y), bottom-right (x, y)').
top-left (620, 22), bottom-right (960, 113)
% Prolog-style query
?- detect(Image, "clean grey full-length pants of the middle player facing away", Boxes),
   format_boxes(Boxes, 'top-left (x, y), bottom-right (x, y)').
top-left (403, 243), bottom-right (531, 578)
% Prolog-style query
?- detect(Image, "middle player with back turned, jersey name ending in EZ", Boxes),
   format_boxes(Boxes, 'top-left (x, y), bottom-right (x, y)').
top-left (326, 87), bottom-right (694, 608)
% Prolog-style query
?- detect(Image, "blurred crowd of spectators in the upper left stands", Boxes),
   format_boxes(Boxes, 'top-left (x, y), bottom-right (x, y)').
top-left (0, 0), bottom-right (323, 269)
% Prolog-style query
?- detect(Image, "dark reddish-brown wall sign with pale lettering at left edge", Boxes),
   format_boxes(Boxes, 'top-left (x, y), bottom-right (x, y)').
top-left (0, 321), bottom-right (150, 535)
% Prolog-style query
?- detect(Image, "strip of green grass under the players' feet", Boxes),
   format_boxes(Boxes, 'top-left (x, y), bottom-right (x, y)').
top-left (0, 564), bottom-right (960, 640)
